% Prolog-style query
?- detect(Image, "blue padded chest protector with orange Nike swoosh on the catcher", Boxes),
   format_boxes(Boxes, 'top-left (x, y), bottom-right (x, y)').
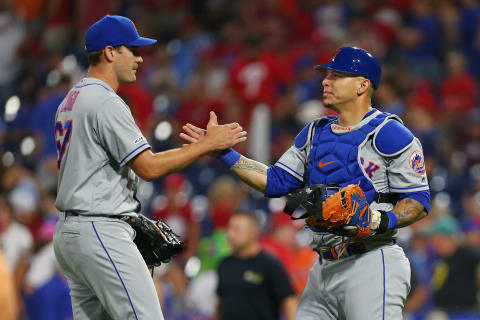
top-left (307, 113), bottom-right (388, 203)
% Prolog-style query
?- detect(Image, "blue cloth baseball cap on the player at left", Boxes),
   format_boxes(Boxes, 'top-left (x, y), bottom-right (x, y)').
top-left (85, 15), bottom-right (157, 52)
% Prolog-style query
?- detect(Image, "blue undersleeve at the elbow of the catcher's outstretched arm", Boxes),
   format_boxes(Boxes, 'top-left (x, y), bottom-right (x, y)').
top-left (265, 165), bottom-right (303, 198)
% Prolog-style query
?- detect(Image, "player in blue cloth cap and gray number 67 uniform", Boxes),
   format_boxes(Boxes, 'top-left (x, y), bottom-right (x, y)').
top-left (54, 16), bottom-right (246, 320)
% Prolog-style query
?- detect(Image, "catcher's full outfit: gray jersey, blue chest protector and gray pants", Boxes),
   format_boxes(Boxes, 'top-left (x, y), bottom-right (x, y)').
top-left (267, 109), bottom-right (428, 320)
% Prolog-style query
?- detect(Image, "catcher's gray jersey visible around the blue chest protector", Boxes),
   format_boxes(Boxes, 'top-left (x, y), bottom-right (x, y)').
top-left (275, 110), bottom-right (429, 249)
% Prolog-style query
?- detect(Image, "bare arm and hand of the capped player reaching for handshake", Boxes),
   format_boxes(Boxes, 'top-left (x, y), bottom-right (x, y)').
top-left (129, 112), bottom-right (247, 181)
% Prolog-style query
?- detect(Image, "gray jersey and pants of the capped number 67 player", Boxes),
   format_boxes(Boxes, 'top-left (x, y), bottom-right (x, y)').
top-left (54, 78), bottom-right (163, 320)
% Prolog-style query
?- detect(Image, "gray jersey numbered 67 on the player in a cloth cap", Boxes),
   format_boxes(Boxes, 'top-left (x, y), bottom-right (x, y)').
top-left (55, 78), bottom-right (150, 215)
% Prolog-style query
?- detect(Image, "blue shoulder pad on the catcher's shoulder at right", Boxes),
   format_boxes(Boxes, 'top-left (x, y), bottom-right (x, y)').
top-left (374, 119), bottom-right (414, 156)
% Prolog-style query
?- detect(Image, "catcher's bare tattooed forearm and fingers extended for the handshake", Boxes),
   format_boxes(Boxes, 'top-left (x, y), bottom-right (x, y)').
top-left (180, 123), bottom-right (268, 193)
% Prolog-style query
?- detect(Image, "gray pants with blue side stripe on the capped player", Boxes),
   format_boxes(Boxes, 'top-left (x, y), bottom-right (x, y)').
top-left (54, 213), bottom-right (163, 320)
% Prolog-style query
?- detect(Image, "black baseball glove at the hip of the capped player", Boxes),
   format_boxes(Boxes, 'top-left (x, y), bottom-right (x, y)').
top-left (125, 214), bottom-right (184, 268)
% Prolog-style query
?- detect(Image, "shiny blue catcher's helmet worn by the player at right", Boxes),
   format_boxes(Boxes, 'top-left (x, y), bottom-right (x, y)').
top-left (314, 47), bottom-right (382, 89)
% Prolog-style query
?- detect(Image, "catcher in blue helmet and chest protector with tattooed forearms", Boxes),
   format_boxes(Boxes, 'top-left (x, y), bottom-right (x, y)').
top-left (181, 47), bottom-right (430, 320)
